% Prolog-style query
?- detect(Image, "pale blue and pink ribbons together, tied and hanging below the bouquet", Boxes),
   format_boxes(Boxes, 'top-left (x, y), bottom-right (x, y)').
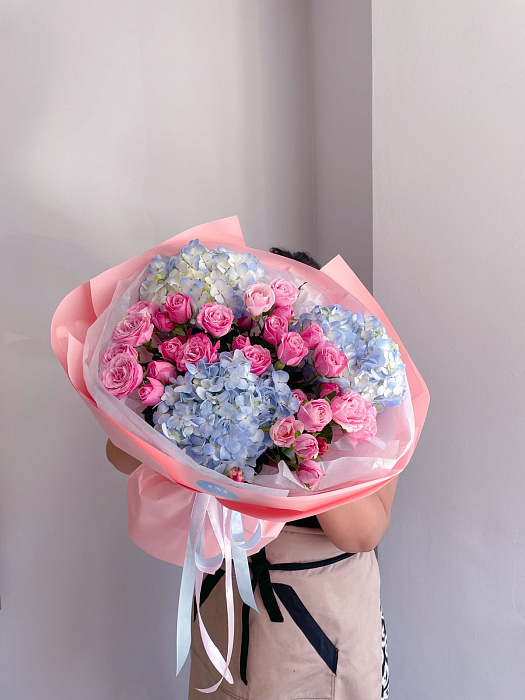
top-left (177, 493), bottom-right (262, 693)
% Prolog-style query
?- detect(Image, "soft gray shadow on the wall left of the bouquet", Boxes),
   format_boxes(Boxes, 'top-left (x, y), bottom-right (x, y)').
top-left (0, 233), bottom-right (187, 700)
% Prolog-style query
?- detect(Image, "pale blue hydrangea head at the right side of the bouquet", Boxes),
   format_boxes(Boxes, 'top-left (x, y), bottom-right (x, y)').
top-left (293, 304), bottom-right (406, 413)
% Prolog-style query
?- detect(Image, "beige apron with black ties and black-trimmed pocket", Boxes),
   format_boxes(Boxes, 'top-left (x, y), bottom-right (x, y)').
top-left (188, 525), bottom-right (382, 700)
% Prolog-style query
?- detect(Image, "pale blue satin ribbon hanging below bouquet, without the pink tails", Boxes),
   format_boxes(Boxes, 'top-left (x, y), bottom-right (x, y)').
top-left (177, 493), bottom-right (262, 675)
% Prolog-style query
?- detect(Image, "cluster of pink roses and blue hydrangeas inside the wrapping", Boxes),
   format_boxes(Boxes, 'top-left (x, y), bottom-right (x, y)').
top-left (99, 239), bottom-right (406, 489)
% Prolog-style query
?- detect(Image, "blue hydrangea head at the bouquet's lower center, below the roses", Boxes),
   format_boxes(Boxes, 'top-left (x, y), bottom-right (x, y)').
top-left (153, 350), bottom-right (299, 481)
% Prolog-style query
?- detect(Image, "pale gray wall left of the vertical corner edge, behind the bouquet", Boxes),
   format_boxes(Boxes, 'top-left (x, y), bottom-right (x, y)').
top-left (0, 0), bottom-right (372, 700)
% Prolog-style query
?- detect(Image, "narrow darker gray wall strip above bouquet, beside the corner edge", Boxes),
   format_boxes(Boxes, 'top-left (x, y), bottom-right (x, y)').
top-left (312, 0), bottom-right (372, 291)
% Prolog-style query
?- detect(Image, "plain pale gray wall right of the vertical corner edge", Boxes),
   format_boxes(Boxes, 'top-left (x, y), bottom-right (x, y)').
top-left (373, 0), bottom-right (525, 700)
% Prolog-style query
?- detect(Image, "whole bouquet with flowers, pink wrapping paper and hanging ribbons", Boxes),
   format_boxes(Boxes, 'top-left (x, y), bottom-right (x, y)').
top-left (51, 217), bottom-right (429, 692)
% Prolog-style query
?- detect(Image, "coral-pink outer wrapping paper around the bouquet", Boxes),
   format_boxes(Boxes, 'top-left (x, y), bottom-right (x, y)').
top-left (51, 216), bottom-right (430, 565)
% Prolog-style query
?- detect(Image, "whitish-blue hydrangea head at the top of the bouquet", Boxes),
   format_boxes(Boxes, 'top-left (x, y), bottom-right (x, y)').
top-left (139, 238), bottom-right (266, 318)
